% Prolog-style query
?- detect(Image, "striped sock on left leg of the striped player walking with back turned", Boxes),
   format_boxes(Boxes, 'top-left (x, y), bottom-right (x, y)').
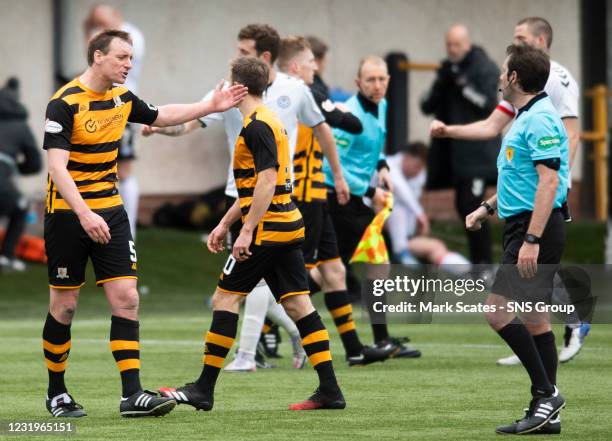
top-left (196, 311), bottom-right (238, 393)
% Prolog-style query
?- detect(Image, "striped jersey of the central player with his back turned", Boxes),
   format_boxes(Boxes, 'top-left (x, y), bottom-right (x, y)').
top-left (233, 105), bottom-right (304, 246)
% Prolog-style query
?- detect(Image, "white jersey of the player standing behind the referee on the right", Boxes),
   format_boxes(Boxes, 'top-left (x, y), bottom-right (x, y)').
top-left (497, 60), bottom-right (580, 118)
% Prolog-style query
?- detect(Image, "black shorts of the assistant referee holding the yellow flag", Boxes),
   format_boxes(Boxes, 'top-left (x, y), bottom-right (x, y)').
top-left (326, 188), bottom-right (375, 265)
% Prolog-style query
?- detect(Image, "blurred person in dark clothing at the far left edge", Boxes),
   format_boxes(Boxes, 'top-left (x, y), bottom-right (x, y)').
top-left (0, 78), bottom-right (41, 271)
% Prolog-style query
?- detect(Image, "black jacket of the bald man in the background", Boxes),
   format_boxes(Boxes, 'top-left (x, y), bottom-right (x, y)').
top-left (421, 46), bottom-right (500, 189)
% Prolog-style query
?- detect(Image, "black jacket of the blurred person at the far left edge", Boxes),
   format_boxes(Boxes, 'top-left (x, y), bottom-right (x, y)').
top-left (0, 88), bottom-right (42, 190)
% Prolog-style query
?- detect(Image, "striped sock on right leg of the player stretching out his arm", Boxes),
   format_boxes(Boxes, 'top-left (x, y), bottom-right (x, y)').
top-left (110, 315), bottom-right (142, 398)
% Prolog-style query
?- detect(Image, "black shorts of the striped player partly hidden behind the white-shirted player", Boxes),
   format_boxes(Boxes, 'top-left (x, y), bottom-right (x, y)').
top-left (294, 200), bottom-right (340, 268)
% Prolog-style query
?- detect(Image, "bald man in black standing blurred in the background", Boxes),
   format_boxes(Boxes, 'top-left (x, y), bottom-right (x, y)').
top-left (421, 24), bottom-right (499, 264)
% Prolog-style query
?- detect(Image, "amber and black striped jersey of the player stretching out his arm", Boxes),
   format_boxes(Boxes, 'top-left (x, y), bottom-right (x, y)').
top-left (43, 78), bottom-right (157, 213)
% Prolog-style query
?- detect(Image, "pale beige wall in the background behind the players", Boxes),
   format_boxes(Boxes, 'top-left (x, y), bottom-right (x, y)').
top-left (10, 0), bottom-right (580, 194)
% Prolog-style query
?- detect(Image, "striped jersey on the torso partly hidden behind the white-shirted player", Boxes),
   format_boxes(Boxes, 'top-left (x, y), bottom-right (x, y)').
top-left (293, 124), bottom-right (327, 202)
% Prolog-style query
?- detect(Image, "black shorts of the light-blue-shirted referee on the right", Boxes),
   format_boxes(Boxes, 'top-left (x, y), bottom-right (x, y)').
top-left (491, 208), bottom-right (565, 303)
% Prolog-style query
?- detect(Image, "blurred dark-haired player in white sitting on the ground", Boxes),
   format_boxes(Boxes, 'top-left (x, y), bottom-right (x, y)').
top-left (385, 142), bottom-right (471, 275)
